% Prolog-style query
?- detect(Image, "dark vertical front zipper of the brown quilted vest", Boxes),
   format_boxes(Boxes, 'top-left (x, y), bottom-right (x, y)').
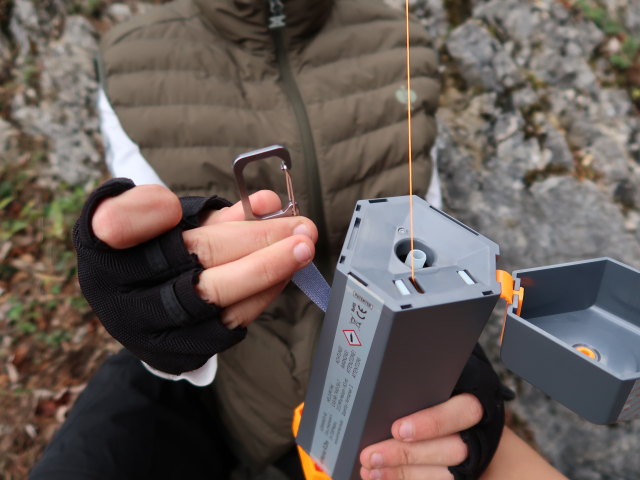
top-left (269, 4), bottom-right (331, 276)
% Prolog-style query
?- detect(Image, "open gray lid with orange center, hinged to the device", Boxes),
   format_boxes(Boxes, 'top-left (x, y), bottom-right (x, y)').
top-left (501, 258), bottom-right (640, 424)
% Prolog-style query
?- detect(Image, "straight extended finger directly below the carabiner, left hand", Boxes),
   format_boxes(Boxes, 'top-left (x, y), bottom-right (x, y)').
top-left (182, 217), bottom-right (318, 268)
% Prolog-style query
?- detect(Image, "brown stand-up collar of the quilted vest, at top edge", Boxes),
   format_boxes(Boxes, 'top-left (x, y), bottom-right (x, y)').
top-left (194, 0), bottom-right (335, 50)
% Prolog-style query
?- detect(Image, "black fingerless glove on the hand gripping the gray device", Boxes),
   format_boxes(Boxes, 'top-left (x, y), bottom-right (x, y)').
top-left (449, 344), bottom-right (515, 480)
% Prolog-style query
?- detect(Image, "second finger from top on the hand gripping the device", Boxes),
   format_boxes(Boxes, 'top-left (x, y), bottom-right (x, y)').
top-left (360, 434), bottom-right (469, 469)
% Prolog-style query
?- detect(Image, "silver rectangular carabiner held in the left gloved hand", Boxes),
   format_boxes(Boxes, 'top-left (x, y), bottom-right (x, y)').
top-left (233, 145), bottom-right (299, 220)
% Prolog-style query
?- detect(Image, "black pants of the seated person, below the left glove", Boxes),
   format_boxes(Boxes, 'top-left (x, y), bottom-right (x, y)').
top-left (29, 351), bottom-right (301, 480)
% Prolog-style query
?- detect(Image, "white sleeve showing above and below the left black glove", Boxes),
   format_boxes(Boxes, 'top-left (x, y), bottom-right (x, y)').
top-left (98, 89), bottom-right (218, 387)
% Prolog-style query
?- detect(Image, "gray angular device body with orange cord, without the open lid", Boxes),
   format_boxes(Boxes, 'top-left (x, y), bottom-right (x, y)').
top-left (297, 196), bottom-right (501, 480)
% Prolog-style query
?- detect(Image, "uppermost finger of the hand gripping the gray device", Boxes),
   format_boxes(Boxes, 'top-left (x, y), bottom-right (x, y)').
top-left (391, 393), bottom-right (483, 441)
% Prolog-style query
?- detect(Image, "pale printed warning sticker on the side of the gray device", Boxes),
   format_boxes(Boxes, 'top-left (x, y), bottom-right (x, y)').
top-left (309, 276), bottom-right (384, 476)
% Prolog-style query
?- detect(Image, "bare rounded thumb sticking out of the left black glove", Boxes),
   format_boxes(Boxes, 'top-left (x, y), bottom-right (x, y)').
top-left (91, 185), bottom-right (182, 249)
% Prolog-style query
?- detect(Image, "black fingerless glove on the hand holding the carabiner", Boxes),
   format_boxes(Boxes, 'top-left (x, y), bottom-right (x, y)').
top-left (73, 178), bottom-right (246, 374)
